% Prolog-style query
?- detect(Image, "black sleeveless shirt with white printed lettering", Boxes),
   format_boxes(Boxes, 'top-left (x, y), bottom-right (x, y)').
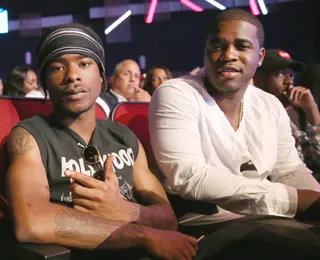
top-left (16, 116), bottom-right (139, 204)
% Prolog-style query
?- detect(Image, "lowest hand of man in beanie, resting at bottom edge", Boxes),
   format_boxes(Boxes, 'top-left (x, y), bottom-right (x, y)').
top-left (145, 229), bottom-right (198, 260)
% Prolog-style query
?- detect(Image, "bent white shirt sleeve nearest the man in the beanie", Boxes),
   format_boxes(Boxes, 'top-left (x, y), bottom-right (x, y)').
top-left (149, 83), bottom-right (297, 217)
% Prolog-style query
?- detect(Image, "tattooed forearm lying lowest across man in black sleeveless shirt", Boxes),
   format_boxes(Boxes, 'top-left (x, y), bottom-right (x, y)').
top-left (55, 208), bottom-right (146, 249)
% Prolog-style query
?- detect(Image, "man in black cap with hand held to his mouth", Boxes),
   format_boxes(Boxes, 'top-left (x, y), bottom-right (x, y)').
top-left (254, 49), bottom-right (320, 175)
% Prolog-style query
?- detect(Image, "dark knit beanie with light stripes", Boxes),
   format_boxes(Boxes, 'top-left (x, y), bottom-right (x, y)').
top-left (37, 23), bottom-right (105, 85)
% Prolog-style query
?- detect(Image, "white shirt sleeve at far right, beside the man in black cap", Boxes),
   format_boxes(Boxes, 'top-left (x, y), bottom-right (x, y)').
top-left (270, 100), bottom-right (320, 191)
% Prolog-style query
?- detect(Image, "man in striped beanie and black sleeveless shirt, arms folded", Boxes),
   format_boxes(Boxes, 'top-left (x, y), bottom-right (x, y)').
top-left (7, 24), bottom-right (197, 259)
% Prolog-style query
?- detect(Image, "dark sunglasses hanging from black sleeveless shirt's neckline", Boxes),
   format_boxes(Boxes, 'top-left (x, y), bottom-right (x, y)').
top-left (81, 145), bottom-right (105, 181)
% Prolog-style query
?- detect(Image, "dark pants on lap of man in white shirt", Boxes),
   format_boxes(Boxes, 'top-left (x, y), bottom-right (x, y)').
top-left (180, 217), bottom-right (320, 260)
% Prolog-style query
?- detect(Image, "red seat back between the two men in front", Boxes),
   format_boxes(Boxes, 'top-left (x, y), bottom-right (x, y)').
top-left (110, 102), bottom-right (164, 183)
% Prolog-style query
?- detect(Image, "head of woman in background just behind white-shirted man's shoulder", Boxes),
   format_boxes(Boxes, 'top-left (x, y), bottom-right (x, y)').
top-left (144, 65), bottom-right (173, 95)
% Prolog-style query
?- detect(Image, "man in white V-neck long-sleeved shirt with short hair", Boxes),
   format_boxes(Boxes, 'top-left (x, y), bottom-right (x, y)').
top-left (149, 9), bottom-right (320, 223)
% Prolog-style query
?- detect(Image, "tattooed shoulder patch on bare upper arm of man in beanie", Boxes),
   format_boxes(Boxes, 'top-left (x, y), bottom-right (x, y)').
top-left (8, 127), bottom-right (33, 157)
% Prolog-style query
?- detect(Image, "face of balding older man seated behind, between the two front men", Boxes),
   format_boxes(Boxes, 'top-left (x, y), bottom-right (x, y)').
top-left (111, 60), bottom-right (141, 101)
